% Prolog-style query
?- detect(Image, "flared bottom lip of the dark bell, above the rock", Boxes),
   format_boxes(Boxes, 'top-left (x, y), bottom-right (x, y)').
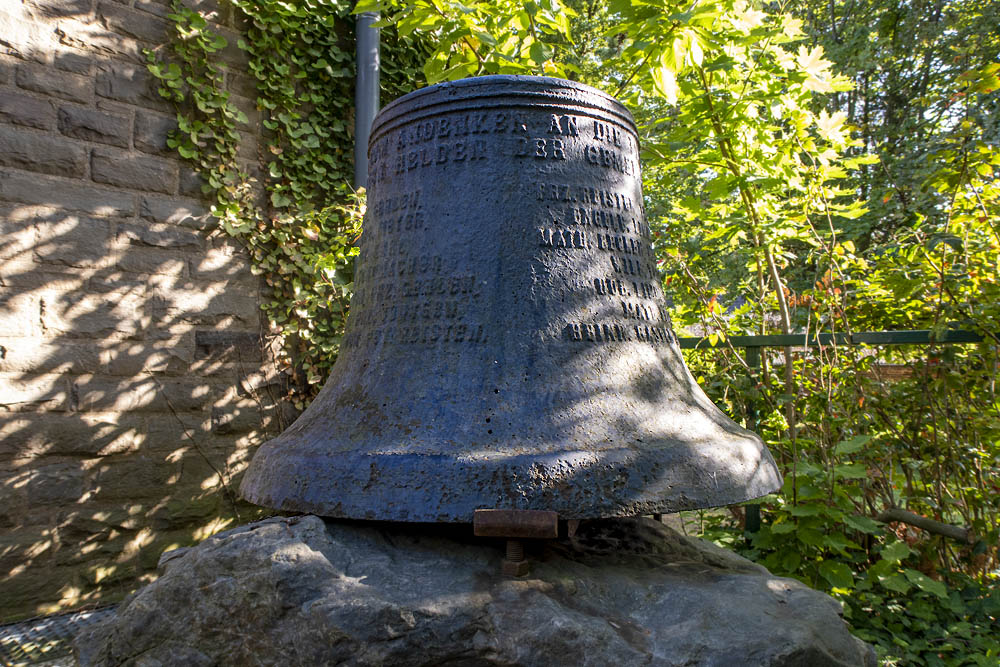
top-left (240, 436), bottom-right (783, 523)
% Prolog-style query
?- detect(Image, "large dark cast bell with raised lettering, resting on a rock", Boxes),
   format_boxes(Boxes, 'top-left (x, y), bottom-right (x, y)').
top-left (242, 76), bottom-right (781, 522)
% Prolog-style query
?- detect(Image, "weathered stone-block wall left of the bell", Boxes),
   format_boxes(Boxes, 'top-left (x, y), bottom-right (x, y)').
top-left (0, 0), bottom-right (279, 619)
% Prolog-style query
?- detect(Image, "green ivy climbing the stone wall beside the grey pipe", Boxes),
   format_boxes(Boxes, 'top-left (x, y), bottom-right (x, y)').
top-left (146, 0), bottom-right (428, 408)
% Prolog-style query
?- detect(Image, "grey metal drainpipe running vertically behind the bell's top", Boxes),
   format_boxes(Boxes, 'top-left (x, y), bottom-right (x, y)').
top-left (354, 12), bottom-right (380, 188)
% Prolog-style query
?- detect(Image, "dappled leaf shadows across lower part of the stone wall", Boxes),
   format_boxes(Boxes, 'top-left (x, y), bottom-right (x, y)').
top-left (0, 198), bottom-right (288, 616)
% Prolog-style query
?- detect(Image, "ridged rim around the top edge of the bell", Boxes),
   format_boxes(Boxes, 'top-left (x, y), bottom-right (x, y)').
top-left (368, 74), bottom-right (638, 150)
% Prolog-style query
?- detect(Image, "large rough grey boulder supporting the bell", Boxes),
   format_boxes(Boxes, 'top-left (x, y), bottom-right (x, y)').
top-left (77, 516), bottom-right (875, 667)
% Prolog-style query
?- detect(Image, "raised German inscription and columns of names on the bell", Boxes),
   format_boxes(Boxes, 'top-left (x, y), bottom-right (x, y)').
top-left (360, 107), bottom-right (656, 350)
